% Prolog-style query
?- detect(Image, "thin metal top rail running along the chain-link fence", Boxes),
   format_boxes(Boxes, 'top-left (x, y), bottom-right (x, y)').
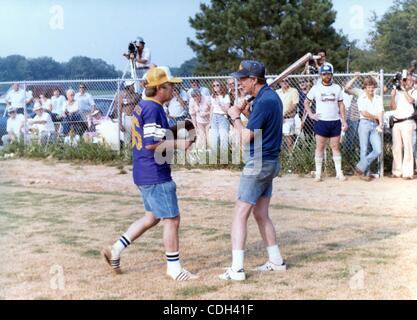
top-left (0, 72), bottom-right (395, 85)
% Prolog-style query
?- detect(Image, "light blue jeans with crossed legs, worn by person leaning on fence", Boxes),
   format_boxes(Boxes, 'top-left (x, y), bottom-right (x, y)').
top-left (356, 119), bottom-right (382, 174)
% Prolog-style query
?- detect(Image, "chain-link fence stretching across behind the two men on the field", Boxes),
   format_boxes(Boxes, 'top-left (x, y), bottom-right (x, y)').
top-left (0, 71), bottom-right (410, 176)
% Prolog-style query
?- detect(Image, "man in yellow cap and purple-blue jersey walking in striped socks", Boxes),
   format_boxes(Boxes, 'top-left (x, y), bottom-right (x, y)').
top-left (102, 67), bottom-right (196, 281)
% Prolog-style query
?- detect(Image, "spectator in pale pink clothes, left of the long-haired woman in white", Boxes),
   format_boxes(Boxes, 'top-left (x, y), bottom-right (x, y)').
top-left (189, 89), bottom-right (211, 149)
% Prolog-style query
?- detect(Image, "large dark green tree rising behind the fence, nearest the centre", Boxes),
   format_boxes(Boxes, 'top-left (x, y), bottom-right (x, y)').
top-left (187, 0), bottom-right (349, 73)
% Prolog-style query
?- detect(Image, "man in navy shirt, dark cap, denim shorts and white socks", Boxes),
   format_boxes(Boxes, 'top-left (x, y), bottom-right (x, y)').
top-left (219, 60), bottom-right (286, 281)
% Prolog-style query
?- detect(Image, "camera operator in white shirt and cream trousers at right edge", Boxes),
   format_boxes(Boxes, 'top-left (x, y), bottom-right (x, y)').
top-left (391, 74), bottom-right (417, 180)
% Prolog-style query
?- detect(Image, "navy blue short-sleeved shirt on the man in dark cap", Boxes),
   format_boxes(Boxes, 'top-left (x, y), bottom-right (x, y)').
top-left (247, 85), bottom-right (283, 160)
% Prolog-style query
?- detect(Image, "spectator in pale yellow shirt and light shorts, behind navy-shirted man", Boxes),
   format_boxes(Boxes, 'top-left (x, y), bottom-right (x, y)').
top-left (276, 78), bottom-right (300, 152)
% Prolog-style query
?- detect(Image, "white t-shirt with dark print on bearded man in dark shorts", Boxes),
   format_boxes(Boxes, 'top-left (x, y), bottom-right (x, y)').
top-left (307, 81), bottom-right (343, 121)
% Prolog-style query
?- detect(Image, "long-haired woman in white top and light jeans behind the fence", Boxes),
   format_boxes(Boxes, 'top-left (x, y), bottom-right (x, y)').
top-left (210, 80), bottom-right (230, 151)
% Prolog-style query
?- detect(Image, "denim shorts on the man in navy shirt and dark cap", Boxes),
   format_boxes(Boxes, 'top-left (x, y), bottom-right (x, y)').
top-left (237, 160), bottom-right (280, 205)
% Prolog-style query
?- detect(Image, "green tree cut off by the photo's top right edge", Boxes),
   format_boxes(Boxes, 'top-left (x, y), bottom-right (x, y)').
top-left (370, 0), bottom-right (417, 71)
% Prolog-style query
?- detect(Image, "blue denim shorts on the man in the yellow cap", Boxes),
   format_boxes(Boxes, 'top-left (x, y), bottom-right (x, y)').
top-left (138, 180), bottom-right (180, 219)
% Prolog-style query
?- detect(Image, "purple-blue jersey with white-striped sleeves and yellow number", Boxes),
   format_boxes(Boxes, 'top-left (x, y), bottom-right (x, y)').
top-left (132, 99), bottom-right (172, 186)
